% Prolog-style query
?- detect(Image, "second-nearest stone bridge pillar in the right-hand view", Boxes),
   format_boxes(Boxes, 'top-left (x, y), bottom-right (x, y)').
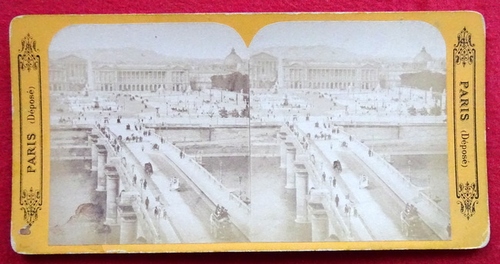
top-left (295, 163), bottom-right (308, 223)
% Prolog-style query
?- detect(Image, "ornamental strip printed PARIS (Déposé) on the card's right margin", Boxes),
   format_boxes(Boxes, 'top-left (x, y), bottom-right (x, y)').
top-left (452, 27), bottom-right (480, 220)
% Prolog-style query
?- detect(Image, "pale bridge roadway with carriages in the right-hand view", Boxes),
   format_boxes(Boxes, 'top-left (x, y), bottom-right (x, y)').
top-left (297, 122), bottom-right (439, 240)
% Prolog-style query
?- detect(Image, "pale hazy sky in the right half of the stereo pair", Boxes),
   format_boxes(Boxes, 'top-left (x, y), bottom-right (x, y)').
top-left (254, 21), bottom-right (446, 58)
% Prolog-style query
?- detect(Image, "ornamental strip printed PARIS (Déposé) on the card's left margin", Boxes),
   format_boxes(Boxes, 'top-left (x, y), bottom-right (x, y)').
top-left (17, 33), bottom-right (43, 235)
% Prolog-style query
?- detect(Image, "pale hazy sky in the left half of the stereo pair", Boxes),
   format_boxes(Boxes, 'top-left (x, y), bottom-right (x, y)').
top-left (49, 23), bottom-right (247, 59)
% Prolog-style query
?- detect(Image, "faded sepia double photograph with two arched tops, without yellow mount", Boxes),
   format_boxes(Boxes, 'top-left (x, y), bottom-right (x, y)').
top-left (48, 20), bottom-right (452, 246)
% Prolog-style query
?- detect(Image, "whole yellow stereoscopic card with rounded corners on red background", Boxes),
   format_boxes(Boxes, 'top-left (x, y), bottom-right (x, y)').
top-left (10, 12), bottom-right (489, 254)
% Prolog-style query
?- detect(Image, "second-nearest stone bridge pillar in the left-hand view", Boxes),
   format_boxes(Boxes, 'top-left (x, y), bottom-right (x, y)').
top-left (105, 165), bottom-right (120, 224)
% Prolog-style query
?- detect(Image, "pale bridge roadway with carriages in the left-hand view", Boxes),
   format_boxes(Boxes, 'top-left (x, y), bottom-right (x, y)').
top-left (108, 124), bottom-right (252, 243)
